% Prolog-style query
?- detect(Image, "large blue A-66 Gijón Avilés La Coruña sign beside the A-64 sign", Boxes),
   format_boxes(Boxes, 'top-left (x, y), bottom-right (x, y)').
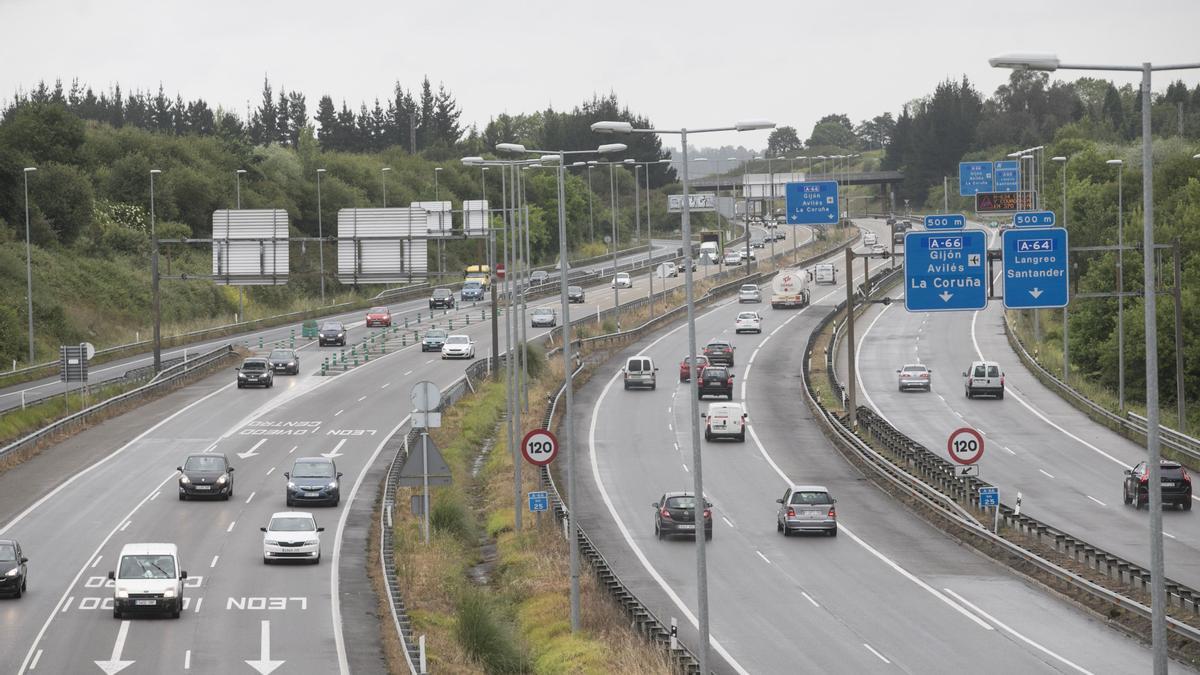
top-left (904, 229), bottom-right (988, 312)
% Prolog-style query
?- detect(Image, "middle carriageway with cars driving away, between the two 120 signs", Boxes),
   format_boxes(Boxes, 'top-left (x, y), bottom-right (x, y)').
top-left (572, 221), bottom-right (1171, 674)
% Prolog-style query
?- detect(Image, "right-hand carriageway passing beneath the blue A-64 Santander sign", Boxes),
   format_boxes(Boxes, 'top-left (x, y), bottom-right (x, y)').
top-left (839, 219), bottom-right (1200, 587)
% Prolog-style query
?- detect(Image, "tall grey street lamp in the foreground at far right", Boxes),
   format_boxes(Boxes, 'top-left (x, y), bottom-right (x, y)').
top-left (989, 54), bottom-right (1200, 675)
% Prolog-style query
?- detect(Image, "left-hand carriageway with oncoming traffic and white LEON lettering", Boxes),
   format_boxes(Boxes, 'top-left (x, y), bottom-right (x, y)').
top-left (0, 224), bottom-right (810, 674)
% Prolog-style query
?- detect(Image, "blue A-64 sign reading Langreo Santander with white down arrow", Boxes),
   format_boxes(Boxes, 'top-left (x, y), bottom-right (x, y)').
top-left (1002, 227), bottom-right (1070, 310)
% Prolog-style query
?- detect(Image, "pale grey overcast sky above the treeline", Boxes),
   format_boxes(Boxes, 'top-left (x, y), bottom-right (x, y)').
top-left (0, 0), bottom-right (1200, 148)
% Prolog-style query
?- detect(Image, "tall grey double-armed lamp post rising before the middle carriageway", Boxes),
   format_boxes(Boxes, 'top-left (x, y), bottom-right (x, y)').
top-left (592, 120), bottom-right (775, 673)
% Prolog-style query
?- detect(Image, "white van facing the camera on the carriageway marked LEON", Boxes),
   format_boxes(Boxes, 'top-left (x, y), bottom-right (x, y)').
top-left (108, 544), bottom-right (187, 619)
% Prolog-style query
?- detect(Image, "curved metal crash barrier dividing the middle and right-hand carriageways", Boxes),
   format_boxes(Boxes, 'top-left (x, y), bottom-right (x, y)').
top-left (803, 270), bottom-right (1200, 644)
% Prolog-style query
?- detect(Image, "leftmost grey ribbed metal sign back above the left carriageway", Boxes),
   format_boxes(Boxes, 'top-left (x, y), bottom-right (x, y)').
top-left (212, 209), bottom-right (289, 286)
